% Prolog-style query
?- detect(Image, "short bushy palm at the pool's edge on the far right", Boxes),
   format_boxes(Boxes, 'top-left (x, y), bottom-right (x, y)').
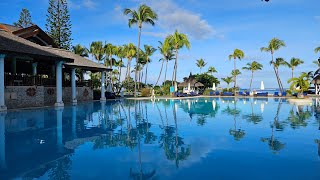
top-left (288, 72), bottom-right (310, 97)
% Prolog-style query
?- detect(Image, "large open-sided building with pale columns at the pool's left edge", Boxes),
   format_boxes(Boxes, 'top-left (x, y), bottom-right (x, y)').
top-left (0, 24), bottom-right (112, 111)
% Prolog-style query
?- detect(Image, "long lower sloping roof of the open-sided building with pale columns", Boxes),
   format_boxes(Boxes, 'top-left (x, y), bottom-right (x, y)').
top-left (0, 30), bottom-right (111, 71)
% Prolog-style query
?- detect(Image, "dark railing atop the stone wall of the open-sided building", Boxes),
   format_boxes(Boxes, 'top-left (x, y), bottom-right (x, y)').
top-left (4, 74), bottom-right (93, 88)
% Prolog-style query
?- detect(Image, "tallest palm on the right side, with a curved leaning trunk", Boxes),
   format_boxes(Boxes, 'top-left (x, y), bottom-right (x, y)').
top-left (260, 38), bottom-right (286, 93)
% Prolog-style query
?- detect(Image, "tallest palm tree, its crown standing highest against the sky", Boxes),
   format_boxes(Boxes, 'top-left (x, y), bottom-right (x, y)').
top-left (123, 4), bottom-right (158, 97)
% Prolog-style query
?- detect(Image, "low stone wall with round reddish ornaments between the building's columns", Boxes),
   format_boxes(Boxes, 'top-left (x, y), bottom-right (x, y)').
top-left (5, 86), bottom-right (93, 109)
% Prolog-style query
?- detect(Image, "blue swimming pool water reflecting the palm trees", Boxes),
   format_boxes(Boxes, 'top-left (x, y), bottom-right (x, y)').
top-left (0, 98), bottom-right (320, 180)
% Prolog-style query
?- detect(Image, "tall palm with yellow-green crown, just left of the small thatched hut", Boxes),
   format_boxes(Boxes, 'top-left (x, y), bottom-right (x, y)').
top-left (167, 30), bottom-right (190, 86)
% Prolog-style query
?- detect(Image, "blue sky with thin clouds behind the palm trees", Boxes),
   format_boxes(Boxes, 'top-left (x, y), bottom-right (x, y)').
top-left (0, 0), bottom-right (320, 87)
